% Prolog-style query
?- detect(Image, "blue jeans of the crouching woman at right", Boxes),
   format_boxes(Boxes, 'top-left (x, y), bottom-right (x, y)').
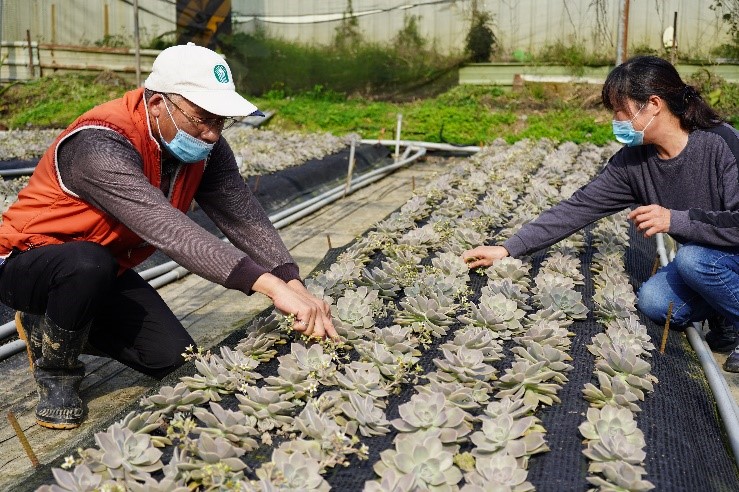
top-left (637, 244), bottom-right (739, 329)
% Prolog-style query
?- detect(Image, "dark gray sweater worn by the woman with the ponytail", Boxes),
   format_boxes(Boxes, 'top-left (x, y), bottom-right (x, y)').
top-left (503, 124), bottom-right (739, 257)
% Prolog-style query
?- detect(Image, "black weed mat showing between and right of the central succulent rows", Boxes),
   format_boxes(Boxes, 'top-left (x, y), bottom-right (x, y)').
top-left (22, 216), bottom-right (739, 492)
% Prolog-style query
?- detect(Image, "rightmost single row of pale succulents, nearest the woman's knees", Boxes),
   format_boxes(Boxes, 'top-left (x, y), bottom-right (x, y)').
top-left (580, 214), bottom-right (657, 492)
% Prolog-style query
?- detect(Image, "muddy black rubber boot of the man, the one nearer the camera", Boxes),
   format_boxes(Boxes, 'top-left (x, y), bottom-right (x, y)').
top-left (34, 317), bottom-right (90, 429)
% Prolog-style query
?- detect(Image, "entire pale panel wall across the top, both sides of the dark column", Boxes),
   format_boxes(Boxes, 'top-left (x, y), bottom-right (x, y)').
top-left (0, 0), bottom-right (728, 55)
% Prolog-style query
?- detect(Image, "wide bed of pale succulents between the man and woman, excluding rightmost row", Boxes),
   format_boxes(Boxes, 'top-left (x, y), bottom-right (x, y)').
top-left (39, 141), bottom-right (636, 491)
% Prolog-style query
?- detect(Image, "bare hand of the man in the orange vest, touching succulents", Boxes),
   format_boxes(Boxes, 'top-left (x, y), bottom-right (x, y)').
top-left (252, 273), bottom-right (338, 339)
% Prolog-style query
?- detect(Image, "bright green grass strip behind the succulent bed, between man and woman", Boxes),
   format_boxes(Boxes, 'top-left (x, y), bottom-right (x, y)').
top-left (254, 86), bottom-right (613, 145)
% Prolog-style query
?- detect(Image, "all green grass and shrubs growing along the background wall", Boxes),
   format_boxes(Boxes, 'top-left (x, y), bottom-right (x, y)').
top-left (0, 13), bottom-right (739, 144)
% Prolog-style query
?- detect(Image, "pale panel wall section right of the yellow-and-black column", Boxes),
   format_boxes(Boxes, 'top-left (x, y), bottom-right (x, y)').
top-left (232, 0), bottom-right (729, 55)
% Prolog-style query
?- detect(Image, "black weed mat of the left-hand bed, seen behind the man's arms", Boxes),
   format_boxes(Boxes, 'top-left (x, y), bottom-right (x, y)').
top-left (0, 145), bottom-right (390, 330)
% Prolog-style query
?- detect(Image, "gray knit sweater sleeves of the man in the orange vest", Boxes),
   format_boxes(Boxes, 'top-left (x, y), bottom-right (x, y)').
top-left (57, 129), bottom-right (298, 294)
